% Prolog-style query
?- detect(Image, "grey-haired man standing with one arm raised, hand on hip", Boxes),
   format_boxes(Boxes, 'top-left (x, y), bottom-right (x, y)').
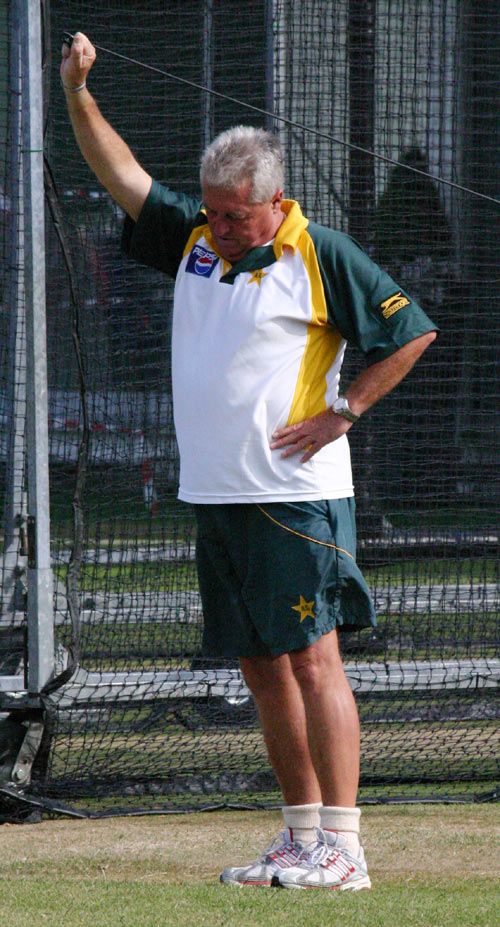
top-left (61, 33), bottom-right (436, 891)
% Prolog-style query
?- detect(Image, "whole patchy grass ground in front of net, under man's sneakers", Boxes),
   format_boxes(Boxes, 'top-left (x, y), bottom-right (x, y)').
top-left (0, 805), bottom-right (500, 927)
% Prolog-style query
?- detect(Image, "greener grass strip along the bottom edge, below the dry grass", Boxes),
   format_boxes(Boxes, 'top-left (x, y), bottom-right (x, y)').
top-left (0, 877), bottom-right (494, 927)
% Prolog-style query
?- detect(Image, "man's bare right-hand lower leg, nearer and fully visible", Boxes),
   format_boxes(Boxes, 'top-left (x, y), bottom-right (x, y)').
top-left (290, 630), bottom-right (360, 808)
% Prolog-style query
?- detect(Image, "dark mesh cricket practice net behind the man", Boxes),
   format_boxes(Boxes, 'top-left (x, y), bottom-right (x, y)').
top-left (0, 0), bottom-right (500, 814)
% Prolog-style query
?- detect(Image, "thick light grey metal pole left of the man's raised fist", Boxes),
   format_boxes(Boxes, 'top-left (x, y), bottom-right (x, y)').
top-left (21, 0), bottom-right (54, 694)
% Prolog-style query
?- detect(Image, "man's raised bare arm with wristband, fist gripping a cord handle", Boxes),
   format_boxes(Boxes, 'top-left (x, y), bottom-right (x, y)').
top-left (61, 32), bottom-right (152, 220)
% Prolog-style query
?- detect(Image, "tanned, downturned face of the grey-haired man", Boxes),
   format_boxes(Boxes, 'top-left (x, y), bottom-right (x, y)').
top-left (203, 183), bottom-right (284, 264)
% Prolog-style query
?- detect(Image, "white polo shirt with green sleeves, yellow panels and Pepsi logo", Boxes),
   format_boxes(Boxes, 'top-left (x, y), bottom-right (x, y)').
top-left (123, 182), bottom-right (436, 503)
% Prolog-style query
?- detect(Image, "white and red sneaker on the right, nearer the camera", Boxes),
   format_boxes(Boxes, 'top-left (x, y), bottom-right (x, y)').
top-left (272, 830), bottom-right (372, 892)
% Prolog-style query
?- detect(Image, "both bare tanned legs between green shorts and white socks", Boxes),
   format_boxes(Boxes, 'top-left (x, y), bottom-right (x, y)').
top-left (240, 631), bottom-right (360, 808)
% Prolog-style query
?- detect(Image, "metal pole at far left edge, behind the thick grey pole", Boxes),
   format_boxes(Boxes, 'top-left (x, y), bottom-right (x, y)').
top-left (1, 3), bottom-right (26, 623)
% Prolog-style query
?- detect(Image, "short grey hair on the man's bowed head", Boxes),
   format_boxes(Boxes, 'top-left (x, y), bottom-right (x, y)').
top-left (200, 126), bottom-right (284, 203)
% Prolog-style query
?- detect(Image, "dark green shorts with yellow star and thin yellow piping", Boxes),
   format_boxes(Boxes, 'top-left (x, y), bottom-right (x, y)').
top-left (194, 498), bottom-right (376, 658)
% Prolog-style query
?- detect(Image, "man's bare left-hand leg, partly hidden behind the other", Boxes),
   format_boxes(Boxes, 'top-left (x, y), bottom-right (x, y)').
top-left (240, 654), bottom-right (321, 805)
